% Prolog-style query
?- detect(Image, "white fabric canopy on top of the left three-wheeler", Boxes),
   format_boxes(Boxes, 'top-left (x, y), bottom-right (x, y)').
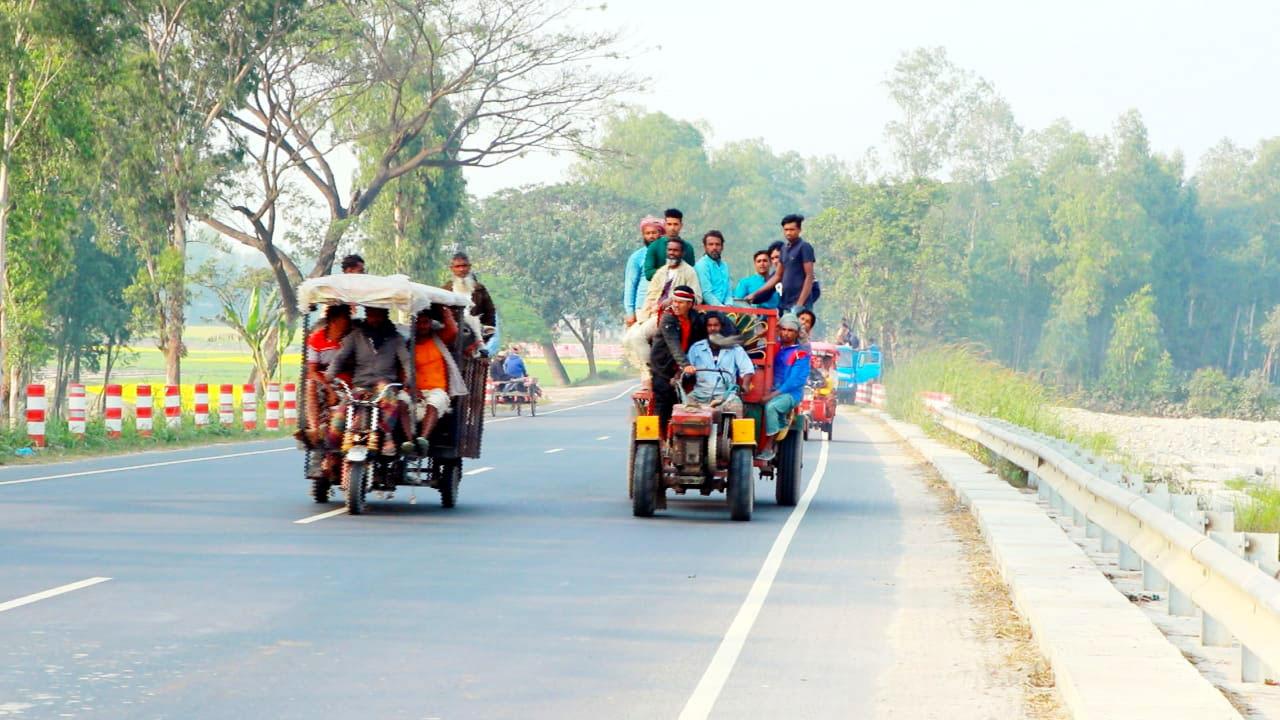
top-left (298, 273), bottom-right (471, 315)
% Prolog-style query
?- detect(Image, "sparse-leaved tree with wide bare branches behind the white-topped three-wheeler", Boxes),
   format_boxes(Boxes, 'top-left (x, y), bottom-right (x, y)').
top-left (211, 0), bottom-right (636, 313)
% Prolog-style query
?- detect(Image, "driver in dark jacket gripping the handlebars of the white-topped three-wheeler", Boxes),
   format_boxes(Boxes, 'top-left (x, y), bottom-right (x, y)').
top-left (325, 307), bottom-right (413, 455)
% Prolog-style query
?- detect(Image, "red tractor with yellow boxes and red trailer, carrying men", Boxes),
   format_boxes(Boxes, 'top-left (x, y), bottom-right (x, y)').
top-left (627, 306), bottom-right (804, 520)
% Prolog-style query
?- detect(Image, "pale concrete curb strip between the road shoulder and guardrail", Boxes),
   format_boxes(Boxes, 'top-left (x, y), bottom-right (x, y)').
top-left (872, 411), bottom-right (1240, 720)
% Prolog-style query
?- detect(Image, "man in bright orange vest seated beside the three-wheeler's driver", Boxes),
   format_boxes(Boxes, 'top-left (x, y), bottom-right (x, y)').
top-left (401, 305), bottom-right (467, 455)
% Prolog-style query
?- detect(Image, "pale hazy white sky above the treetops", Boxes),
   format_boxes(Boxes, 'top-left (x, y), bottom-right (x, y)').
top-left (467, 0), bottom-right (1280, 195)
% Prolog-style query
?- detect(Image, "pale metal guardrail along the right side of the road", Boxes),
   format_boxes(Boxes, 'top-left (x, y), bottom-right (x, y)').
top-left (929, 402), bottom-right (1280, 683)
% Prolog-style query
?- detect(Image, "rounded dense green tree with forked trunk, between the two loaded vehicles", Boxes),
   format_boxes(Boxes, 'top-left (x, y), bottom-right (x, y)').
top-left (476, 184), bottom-right (640, 383)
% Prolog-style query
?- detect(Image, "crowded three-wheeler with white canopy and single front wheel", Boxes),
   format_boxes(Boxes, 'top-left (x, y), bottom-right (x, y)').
top-left (298, 273), bottom-right (488, 515)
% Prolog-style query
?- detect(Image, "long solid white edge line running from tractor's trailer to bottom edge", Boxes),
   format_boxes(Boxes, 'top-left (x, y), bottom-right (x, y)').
top-left (680, 439), bottom-right (829, 720)
